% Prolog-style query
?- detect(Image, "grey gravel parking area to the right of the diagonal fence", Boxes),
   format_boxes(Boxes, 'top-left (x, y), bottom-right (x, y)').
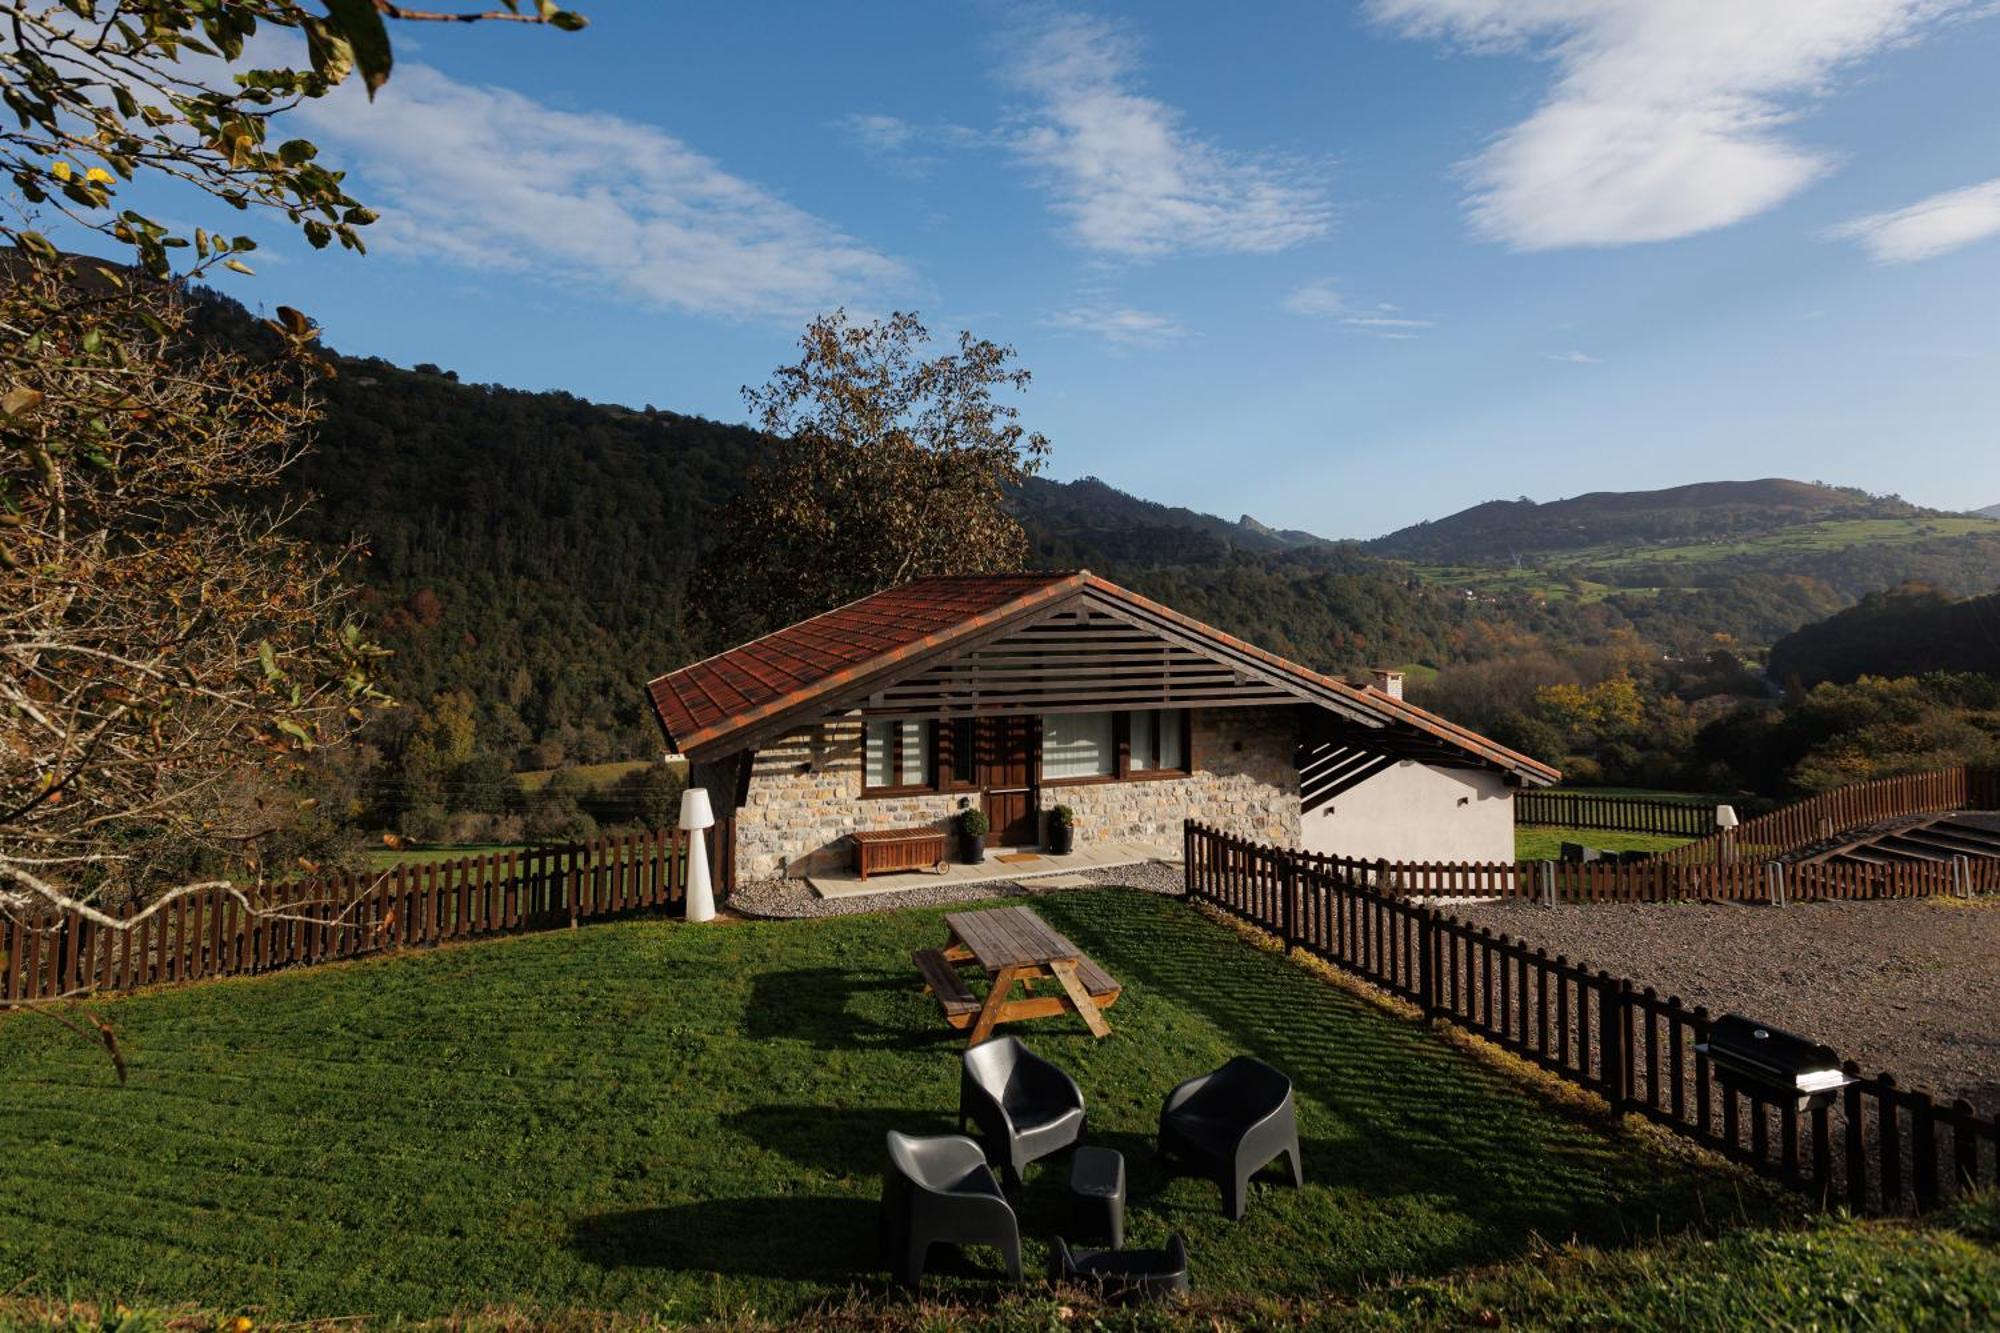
top-left (1450, 899), bottom-right (2000, 1115)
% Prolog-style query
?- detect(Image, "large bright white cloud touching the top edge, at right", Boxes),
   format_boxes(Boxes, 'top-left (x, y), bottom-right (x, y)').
top-left (1370, 0), bottom-right (1974, 250)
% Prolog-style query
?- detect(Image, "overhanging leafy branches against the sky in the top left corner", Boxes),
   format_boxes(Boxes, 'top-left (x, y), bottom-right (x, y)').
top-left (0, 0), bottom-right (584, 276)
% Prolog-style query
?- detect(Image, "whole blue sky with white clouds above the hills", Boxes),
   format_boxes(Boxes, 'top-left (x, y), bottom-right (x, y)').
top-left (133, 0), bottom-right (2000, 536)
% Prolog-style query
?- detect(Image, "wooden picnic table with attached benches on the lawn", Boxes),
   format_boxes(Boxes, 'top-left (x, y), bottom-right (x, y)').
top-left (910, 907), bottom-right (1120, 1047)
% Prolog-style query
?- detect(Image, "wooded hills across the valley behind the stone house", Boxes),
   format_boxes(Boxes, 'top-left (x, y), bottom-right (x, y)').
top-left (172, 278), bottom-right (2000, 820)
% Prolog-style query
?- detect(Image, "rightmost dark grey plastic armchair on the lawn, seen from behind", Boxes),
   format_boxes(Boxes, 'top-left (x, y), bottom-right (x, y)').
top-left (1160, 1055), bottom-right (1306, 1221)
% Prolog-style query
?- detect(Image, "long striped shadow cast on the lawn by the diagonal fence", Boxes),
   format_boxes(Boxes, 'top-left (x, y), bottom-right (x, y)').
top-left (1040, 893), bottom-right (1778, 1265)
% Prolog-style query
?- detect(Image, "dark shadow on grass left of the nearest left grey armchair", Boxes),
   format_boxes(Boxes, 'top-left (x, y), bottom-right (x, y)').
top-left (570, 1197), bottom-right (882, 1283)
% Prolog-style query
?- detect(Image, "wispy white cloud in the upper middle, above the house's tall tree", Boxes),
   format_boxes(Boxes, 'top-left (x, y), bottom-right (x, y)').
top-left (1002, 16), bottom-right (1332, 258)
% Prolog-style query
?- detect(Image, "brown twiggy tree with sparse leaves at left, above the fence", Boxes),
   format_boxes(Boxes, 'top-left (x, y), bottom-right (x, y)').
top-left (0, 258), bottom-right (382, 925)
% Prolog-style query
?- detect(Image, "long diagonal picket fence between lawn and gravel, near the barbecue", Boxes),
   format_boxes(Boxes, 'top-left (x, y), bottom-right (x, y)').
top-left (1184, 821), bottom-right (2000, 1213)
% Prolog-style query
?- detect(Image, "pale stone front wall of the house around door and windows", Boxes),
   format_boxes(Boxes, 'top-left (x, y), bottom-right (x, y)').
top-left (728, 709), bottom-right (1298, 881)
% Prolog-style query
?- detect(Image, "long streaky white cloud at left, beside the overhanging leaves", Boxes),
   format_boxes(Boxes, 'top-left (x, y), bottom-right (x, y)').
top-left (294, 64), bottom-right (914, 320)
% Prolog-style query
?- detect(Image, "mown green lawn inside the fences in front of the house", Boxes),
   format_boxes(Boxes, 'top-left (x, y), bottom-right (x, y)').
top-left (0, 891), bottom-right (1788, 1323)
